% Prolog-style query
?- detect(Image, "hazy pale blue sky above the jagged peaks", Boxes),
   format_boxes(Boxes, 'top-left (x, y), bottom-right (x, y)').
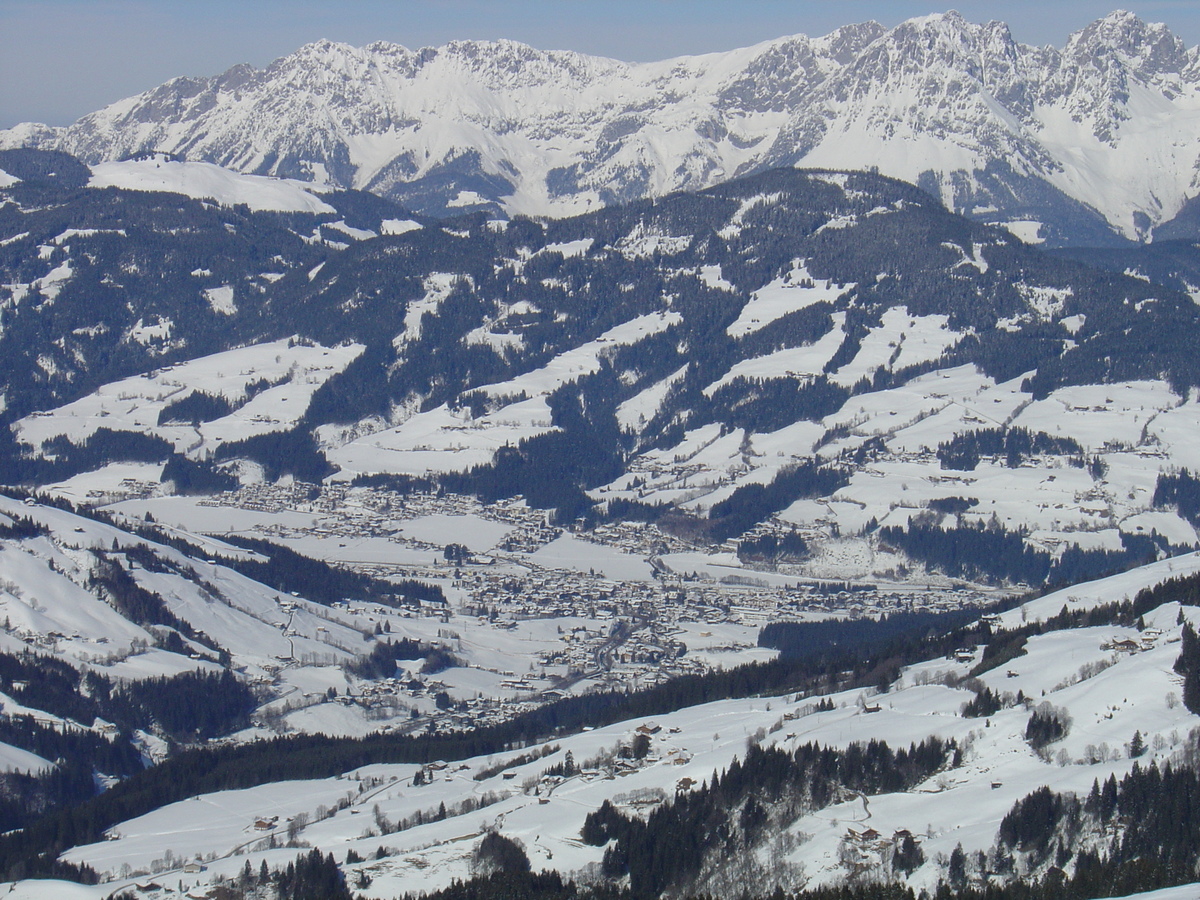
top-left (0, 0), bottom-right (1200, 128)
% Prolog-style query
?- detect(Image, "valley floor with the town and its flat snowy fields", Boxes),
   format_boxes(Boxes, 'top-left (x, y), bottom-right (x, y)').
top-left (82, 482), bottom-right (991, 740)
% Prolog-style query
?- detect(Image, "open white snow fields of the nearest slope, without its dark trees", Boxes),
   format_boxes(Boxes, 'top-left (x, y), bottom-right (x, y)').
top-left (11, 558), bottom-right (1200, 900)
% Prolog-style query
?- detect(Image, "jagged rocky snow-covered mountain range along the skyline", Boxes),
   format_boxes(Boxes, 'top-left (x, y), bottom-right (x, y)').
top-left (0, 12), bottom-right (1200, 245)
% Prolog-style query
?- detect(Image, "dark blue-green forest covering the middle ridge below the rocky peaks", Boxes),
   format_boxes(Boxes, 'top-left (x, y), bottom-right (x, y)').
top-left (7, 151), bottom-right (1200, 547)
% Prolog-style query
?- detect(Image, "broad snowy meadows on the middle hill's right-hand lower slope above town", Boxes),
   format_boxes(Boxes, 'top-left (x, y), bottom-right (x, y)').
top-left (614, 357), bottom-right (1200, 564)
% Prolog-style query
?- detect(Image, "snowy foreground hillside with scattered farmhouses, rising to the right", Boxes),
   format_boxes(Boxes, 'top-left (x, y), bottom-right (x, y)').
top-left (2, 559), bottom-right (1198, 900)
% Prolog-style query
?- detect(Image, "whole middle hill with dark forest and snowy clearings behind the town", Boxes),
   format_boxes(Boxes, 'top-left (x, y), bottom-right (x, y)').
top-left (7, 160), bottom-right (1200, 583)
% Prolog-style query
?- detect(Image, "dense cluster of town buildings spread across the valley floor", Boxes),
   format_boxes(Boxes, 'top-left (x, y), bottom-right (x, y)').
top-left (177, 484), bottom-right (982, 732)
